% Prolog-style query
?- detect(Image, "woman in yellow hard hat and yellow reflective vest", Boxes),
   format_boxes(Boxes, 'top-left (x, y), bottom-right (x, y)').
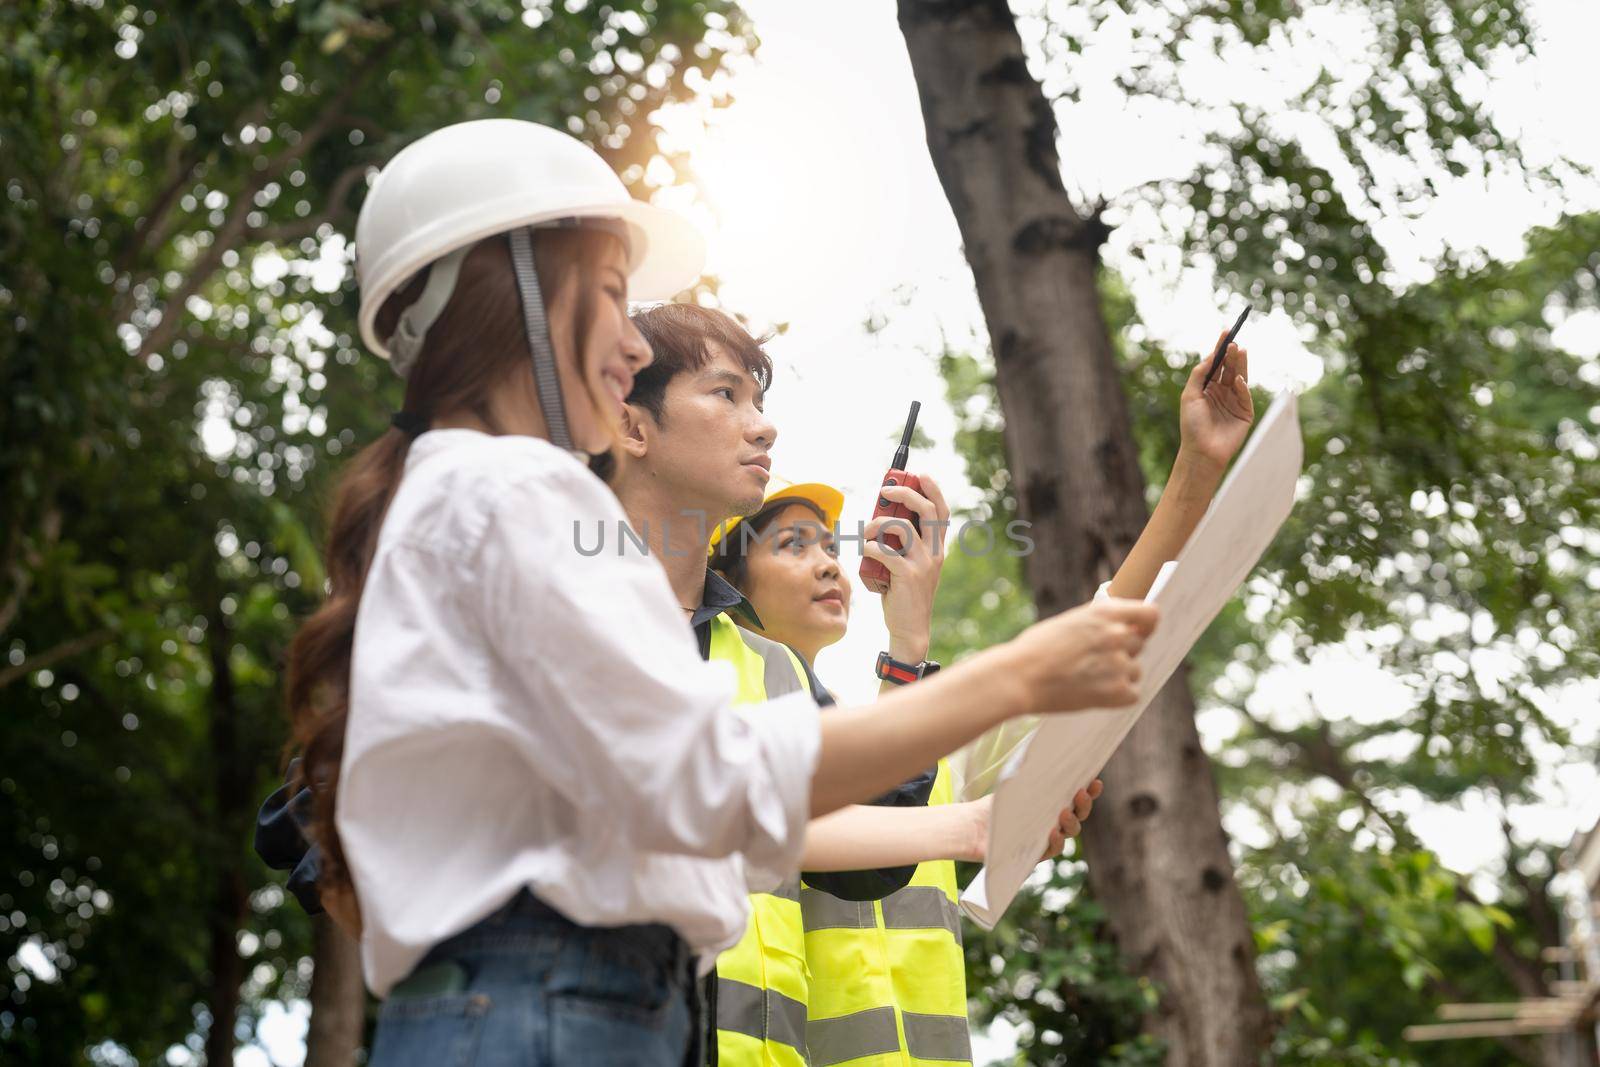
top-left (710, 475), bottom-right (1101, 1067)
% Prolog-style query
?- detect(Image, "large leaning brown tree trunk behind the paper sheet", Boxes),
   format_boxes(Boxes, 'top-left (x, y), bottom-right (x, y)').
top-left (899, 0), bottom-right (1270, 1067)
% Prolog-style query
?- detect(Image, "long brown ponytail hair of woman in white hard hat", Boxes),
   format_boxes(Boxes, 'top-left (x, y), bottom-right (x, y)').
top-left (286, 229), bottom-right (616, 889)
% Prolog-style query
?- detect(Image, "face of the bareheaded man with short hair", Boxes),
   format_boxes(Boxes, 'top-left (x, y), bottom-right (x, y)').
top-left (634, 341), bottom-right (778, 526)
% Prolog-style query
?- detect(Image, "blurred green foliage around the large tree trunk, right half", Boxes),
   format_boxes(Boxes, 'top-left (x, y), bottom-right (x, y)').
top-left (934, 2), bottom-right (1600, 1049)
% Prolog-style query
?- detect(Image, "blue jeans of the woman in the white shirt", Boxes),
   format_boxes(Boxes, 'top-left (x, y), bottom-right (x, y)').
top-left (368, 893), bottom-right (702, 1067)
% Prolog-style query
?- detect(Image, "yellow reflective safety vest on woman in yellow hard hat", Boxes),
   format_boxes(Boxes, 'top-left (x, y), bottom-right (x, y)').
top-left (800, 760), bottom-right (973, 1067)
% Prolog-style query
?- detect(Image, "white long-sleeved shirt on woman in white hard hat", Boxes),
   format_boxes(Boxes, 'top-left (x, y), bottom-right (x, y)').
top-left (336, 430), bottom-right (819, 997)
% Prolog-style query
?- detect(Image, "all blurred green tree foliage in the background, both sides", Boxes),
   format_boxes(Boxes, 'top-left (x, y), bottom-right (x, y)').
top-left (0, 0), bottom-right (1600, 1065)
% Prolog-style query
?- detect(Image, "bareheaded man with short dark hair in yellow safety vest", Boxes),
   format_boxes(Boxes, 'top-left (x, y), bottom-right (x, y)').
top-left (594, 304), bottom-right (933, 1067)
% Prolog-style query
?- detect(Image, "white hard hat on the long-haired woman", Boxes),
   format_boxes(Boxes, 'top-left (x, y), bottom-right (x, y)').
top-left (355, 118), bottom-right (706, 363)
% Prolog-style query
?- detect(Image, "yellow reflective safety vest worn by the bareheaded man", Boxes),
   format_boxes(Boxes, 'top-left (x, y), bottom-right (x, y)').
top-left (707, 614), bottom-right (810, 1067)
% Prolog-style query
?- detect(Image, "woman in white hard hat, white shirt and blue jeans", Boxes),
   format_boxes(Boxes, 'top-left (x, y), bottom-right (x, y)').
top-left (288, 120), bottom-right (1154, 1067)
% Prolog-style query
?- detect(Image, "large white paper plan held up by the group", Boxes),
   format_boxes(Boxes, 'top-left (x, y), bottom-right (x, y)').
top-left (962, 394), bottom-right (1302, 929)
